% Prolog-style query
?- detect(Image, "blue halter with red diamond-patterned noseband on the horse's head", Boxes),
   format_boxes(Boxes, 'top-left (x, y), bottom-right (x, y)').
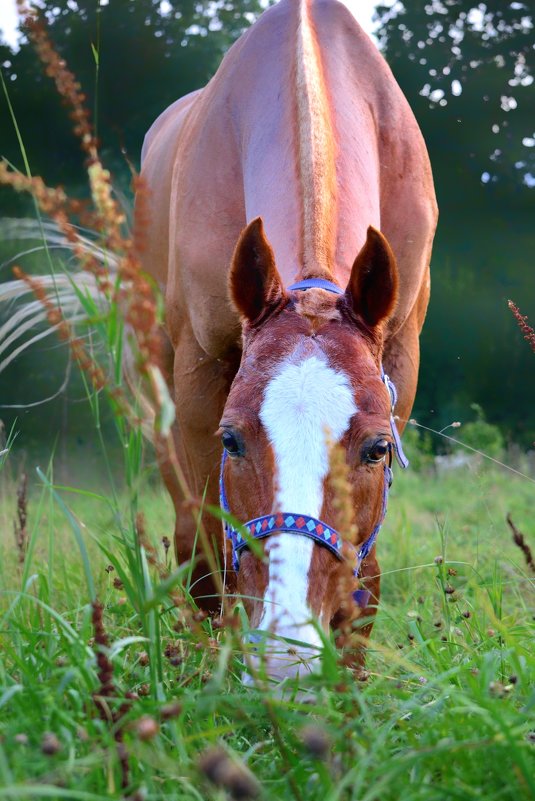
top-left (219, 278), bottom-right (409, 608)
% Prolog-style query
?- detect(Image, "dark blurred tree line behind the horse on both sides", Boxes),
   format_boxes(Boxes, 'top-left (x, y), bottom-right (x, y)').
top-left (0, 0), bottom-right (535, 462)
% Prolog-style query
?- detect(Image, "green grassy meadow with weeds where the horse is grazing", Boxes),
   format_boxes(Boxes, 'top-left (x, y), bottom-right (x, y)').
top-left (0, 440), bottom-right (535, 801)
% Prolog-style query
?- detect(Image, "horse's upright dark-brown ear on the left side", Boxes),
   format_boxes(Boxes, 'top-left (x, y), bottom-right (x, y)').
top-left (230, 217), bottom-right (284, 323)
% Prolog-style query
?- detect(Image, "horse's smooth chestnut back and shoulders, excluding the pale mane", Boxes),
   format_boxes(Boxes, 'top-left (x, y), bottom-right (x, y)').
top-left (143, 0), bottom-right (436, 340)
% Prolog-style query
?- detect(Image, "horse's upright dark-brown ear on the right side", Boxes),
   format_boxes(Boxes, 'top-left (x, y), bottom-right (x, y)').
top-left (346, 225), bottom-right (398, 328)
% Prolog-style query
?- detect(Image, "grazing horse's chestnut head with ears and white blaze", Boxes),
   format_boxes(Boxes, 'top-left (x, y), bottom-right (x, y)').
top-left (221, 219), bottom-right (397, 679)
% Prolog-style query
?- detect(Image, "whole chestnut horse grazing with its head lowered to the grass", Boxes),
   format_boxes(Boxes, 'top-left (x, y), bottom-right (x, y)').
top-left (142, 0), bottom-right (437, 679)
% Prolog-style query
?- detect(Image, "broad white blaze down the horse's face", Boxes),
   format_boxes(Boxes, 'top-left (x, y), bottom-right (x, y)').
top-left (260, 355), bottom-right (357, 646)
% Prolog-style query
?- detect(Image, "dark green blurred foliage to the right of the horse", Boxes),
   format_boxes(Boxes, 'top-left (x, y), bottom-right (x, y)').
top-left (378, 0), bottom-right (535, 446)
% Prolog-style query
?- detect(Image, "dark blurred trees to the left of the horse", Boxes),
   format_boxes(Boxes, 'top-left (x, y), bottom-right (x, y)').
top-left (0, 0), bottom-right (261, 449)
